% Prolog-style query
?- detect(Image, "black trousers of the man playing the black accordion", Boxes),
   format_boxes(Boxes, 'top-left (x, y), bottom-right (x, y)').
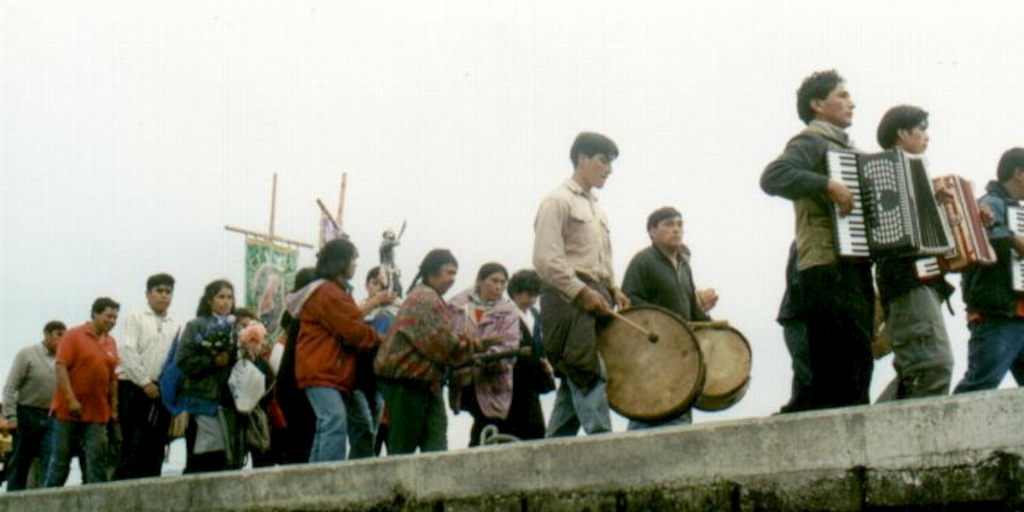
top-left (800, 260), bottom-right (874, 410)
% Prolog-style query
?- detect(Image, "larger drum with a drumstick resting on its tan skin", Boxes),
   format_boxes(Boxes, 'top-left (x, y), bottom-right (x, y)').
top-left (597, 306), bottom-right (705, 421)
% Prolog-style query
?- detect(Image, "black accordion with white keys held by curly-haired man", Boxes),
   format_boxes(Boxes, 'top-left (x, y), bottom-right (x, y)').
top-left (827, 150), bottom-right (953, 258)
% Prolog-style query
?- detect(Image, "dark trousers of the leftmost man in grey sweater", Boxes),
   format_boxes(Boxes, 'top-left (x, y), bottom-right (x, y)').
top-left (4, 406), bottom-right (53, 492)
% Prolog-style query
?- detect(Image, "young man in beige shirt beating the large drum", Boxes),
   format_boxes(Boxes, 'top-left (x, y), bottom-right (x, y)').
top-left (534, 132), bottom-right (629, 437)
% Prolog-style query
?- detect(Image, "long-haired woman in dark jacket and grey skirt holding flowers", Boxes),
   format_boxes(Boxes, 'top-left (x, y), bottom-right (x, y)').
top-left (176, 280), bottom-right (238, 473)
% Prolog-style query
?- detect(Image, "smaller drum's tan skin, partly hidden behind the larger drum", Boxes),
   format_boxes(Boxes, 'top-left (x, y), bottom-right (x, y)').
top-left (693, 328), bottom-right (752, 411)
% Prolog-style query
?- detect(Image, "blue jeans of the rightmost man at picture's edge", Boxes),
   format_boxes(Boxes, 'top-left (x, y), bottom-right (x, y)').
top-left (953, 316), bottom-right (1024, 393)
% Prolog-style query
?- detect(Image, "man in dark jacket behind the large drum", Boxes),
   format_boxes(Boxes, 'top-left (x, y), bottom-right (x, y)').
top-left (623, 206), bottom-right (718, 430)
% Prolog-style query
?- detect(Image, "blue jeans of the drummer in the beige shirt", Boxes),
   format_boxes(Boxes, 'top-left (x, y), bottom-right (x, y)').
top-left (545, 378), bottom-right (611, 437)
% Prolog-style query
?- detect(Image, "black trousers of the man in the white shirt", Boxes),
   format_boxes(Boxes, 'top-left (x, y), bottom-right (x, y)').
top-left (114, 381), bottom-right (171, 480)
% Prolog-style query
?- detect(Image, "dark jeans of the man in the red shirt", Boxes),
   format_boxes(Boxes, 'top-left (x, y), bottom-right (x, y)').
top-left (43, 420), bottom-right (108, 487)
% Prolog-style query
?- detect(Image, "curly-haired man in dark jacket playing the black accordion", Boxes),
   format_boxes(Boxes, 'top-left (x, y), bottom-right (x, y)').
top-left (761, 71), bottom-right (874, 410)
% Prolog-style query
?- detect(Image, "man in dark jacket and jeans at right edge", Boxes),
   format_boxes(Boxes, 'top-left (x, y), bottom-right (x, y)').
top-left (953, 147), bottom-right (1024, 393)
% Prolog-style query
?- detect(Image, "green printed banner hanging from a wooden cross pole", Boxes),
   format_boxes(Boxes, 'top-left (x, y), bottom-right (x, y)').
top-left (246, 237), bottom-right (299, 339)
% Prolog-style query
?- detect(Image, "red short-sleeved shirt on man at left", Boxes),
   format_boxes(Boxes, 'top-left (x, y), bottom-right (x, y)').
top-left (50, 324), bottom-right (118, 423)
